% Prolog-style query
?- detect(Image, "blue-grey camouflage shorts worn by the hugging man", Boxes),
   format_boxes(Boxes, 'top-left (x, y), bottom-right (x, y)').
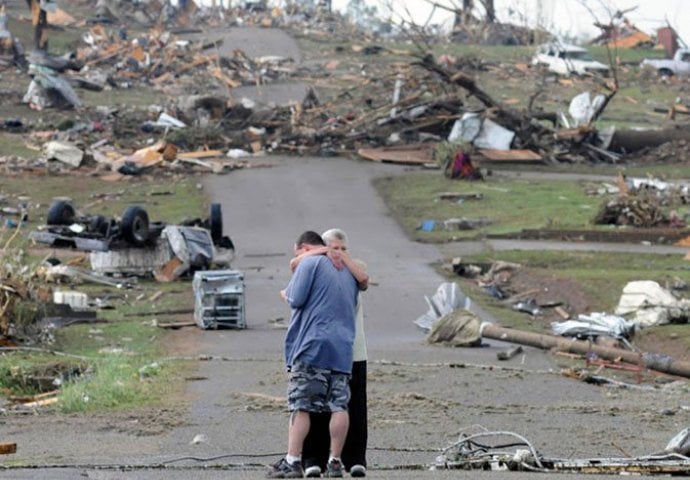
top-left (288, 363), bottom-right (350, 412)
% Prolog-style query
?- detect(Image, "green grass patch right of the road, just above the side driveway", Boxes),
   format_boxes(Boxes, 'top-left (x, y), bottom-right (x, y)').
top-left (375, 171), bottom-right (602, 242)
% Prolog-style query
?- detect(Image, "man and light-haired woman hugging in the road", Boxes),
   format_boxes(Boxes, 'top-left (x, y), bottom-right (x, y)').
top-left (268, 229), bottom-right (369, 478)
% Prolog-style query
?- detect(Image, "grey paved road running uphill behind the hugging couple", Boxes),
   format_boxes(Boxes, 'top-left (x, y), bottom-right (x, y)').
top-left (0, 26), bottom-right (690, 480)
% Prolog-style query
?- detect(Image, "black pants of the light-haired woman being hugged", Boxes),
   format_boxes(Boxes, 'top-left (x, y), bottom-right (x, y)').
top-left (302, 360), bottom-right (368, 471)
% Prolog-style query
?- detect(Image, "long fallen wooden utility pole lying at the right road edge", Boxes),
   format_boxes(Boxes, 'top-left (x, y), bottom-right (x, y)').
top-left (480, 323), bottom-right (690, 378)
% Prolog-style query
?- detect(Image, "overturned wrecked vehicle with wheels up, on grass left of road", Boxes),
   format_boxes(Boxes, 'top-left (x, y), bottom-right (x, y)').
top-left (29, 200), bottom-right (235, 281)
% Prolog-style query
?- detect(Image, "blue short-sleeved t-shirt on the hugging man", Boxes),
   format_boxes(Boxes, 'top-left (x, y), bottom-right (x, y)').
top-left (285, 255), bottom-right (358, 373)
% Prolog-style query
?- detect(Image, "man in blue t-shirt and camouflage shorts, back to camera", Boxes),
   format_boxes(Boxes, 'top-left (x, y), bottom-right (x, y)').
top-left (268, 231), bottom-right (358, 478)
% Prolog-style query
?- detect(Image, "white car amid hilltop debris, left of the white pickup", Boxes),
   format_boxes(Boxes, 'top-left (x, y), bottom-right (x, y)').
top-left (532, 42), bottom-right (609, 76)
